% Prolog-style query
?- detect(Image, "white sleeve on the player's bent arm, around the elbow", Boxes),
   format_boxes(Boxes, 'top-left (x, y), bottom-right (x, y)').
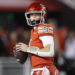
top-left (38, 36), bottom-right (54, 57)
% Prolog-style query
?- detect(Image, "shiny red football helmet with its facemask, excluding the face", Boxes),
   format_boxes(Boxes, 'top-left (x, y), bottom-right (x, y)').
top-left (25, 3), bottom-right (46, 26)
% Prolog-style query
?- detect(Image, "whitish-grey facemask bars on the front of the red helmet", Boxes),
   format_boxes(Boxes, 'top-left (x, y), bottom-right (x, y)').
top-left (25, 11), bottom-right (45, 26)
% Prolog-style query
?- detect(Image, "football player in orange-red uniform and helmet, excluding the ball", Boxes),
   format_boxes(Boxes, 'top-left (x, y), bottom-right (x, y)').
top-left (16, 3), bottom-right (59, 75)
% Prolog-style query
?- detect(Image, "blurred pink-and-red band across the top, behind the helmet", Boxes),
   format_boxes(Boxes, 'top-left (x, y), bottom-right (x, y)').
top-left (0, 0), bottom-right (60, 11)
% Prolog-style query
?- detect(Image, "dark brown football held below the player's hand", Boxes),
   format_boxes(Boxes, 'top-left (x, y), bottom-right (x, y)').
top-left (14, 51), bottom-right (28, 64)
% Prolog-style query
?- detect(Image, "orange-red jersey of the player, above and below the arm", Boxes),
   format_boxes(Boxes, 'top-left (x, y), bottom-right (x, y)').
top-left (30, 24), bottom-right (55, 68)
